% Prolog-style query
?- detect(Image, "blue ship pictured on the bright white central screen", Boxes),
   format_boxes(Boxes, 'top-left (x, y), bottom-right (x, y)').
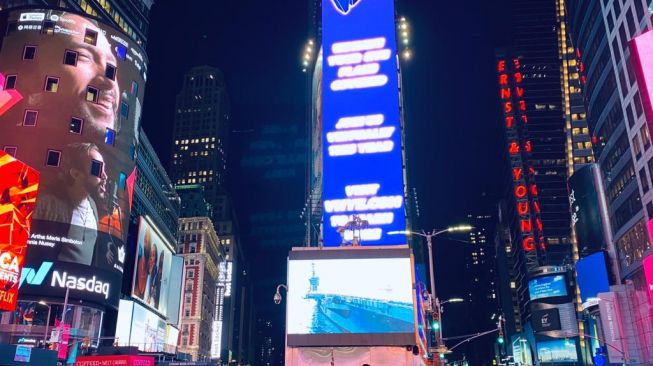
top-left (304, 266), bottom-right (414, 333)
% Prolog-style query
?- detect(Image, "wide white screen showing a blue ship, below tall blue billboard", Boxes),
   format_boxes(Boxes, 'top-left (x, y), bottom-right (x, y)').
top-left (287, 249), bottom-right (415, 346)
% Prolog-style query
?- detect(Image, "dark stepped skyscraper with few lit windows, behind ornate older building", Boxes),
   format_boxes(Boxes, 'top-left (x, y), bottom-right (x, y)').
top-left (170, 66), bottom-right (229, 216)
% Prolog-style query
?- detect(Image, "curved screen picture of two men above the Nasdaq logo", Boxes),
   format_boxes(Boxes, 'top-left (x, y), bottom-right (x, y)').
top-left (0, 9), bottom-right (146, 306)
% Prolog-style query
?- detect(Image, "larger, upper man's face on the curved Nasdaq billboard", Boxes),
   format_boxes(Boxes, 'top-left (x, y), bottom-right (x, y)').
top-left (61, 14), bottom-right (120, 134)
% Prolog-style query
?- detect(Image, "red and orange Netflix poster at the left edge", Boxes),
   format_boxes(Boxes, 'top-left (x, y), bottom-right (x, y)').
top-left (0, 151), bottom-right (39, 311)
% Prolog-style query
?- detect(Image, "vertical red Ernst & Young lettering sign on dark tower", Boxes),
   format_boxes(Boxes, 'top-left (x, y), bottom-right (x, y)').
top-left (497, 58), bottom-right (545, 268)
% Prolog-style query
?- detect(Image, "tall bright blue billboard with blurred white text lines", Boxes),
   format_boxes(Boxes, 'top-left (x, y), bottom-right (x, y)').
top-left (322, 0), bottom-right (406, 246)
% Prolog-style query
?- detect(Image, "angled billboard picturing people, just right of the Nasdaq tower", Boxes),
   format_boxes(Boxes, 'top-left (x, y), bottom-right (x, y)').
top-left (132, 217), bottom-right (183, 323)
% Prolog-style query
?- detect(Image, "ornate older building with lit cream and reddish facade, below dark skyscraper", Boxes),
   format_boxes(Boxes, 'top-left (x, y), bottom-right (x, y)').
top-left (177, 216), bottom-right (225, 361)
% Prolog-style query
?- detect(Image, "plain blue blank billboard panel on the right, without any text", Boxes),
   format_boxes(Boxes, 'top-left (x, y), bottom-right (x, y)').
top-left (576, 252), bottom-right (610, 304)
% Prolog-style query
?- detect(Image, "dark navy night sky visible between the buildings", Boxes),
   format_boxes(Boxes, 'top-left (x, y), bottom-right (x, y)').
top-left (143, 0), bottom-right (505, 360)
